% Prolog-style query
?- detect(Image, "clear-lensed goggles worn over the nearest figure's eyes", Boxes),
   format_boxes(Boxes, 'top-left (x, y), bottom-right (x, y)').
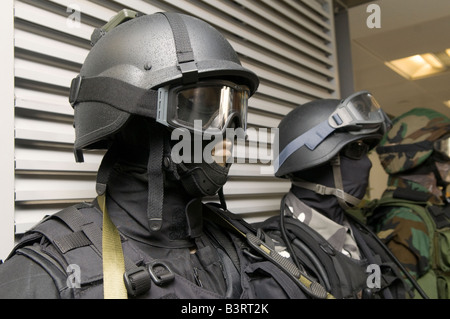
top-left (156, 81), bottom-right (250, 134)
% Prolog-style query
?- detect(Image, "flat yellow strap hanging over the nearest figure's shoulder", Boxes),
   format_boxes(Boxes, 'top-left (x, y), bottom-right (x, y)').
top-left (97, 195), bottom-right (128, 299)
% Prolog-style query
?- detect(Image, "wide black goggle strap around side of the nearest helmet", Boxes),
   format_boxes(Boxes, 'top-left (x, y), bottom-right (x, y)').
top-left (69, 76), bottom-right (158, 118)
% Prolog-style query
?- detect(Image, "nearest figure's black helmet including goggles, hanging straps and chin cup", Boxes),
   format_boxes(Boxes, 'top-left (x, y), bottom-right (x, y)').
top-left (69, 10), bottom-right (259, 231)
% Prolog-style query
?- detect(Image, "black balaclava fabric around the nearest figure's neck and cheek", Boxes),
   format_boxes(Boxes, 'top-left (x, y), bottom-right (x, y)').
top-left (103, 118), bottom-right (202, 248)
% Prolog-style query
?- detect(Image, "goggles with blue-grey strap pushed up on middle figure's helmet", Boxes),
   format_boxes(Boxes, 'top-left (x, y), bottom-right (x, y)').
top-left (274, 91), bottom-right (392, 170)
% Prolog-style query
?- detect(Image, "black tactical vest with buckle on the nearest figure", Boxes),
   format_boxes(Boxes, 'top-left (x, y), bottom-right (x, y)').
top-left (9, 204), bottom-right (320, 299)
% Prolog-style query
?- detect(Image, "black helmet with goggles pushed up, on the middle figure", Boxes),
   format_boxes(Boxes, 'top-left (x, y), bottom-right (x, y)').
top-left (274, 92), bottom-right (389, 178)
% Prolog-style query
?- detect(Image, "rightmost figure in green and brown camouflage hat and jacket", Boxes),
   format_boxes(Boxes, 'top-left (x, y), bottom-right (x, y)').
top-left (367, 108), bottom-right (450, 298)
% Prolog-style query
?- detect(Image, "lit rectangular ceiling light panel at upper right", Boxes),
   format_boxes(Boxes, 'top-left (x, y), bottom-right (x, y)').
top-left (385, 53), bottom-right (445, 80)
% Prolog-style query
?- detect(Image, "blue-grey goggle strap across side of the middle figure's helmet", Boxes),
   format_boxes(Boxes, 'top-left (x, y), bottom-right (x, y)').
top-left (274, 119), bottom-right (335, 175)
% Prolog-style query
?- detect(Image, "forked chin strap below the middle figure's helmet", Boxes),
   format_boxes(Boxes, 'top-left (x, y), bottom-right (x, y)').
top-left (292, 154), bottom-right (361, 210)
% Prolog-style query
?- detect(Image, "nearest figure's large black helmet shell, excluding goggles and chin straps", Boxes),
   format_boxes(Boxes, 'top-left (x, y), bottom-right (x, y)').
top-left (70, 13), bottom-right (259, 161)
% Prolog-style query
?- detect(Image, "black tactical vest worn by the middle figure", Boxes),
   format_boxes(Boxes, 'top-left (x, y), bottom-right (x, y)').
top-left (260, 216), bottom-right (406, 299)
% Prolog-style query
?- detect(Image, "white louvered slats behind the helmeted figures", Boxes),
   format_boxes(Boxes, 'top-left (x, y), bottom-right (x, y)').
top-left (11, 0), bottom-right (339, 248)
